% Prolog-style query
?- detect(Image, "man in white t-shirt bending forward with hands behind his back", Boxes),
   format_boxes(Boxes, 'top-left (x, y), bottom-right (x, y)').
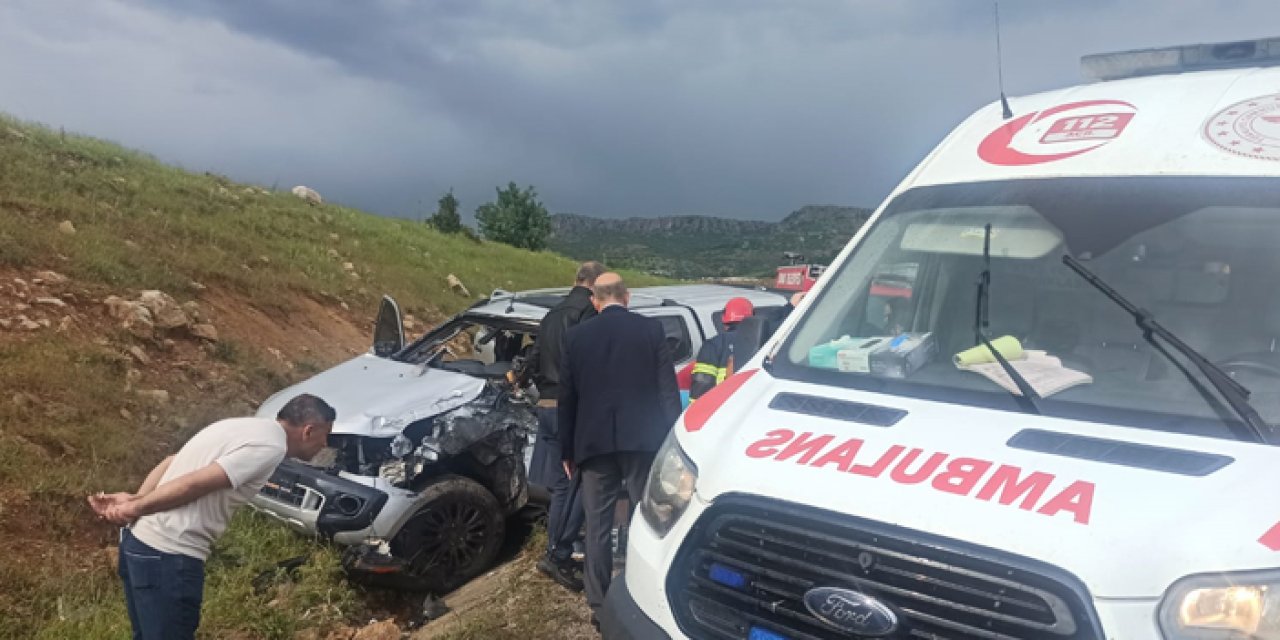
top-left (88, 394), bottom-right (334, 640)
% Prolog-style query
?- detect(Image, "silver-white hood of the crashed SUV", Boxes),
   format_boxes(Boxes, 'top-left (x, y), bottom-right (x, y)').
top-left (257, 353), bottom-right (485, 438)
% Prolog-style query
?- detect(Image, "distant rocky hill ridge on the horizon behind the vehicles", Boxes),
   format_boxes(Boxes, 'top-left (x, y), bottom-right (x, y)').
top-left (550, 206), bottom-right (870, 278)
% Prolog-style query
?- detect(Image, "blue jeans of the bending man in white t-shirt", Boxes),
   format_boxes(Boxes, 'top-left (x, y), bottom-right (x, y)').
top-left (119, 529), bottom-right (205, 640)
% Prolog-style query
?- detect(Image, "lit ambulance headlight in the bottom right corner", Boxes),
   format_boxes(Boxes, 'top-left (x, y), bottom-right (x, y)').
top-left (1160, 571), bottom-right (1280, 640)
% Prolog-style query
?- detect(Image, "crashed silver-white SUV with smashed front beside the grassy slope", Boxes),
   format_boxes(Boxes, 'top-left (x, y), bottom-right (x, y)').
top-left (252, 285), bottom-right (786, 593)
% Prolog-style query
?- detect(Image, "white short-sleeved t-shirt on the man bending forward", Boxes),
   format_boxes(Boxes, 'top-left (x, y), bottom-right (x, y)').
top-left (131, 417), bottom-right (287, 559)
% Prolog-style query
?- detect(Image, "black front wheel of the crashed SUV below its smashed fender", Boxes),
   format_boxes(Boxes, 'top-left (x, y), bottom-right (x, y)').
top-left (390, 476), bottom-right (506, 595)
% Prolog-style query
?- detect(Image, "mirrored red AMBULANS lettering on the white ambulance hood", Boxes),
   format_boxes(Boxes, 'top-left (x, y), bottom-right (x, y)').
top-left (746, 429), bottom-right (1095, 524)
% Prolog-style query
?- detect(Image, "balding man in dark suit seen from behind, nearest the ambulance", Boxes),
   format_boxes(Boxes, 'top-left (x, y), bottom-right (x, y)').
top-left (557, 273), bottom-right (681, 620)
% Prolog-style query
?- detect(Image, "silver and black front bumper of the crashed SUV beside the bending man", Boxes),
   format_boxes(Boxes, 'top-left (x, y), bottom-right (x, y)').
top-left (251, 460), bottom-right (388, 538)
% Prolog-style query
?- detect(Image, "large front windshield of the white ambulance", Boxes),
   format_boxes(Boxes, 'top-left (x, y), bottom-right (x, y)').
top-left (773, 177), bottom-right (1280, 438)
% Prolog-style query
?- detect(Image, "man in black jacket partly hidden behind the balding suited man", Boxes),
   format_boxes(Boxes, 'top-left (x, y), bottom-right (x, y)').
top-left (530, 261), bottom-right (604, 590)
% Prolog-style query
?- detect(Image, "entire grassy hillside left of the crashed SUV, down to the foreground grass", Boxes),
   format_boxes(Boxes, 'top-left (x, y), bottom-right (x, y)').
top-left (0, 116), bottom-right (665, 639)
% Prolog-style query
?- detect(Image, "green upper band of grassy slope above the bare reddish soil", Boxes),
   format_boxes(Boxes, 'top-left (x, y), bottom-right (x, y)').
top-left (0, 118), bottom-right (660, 312)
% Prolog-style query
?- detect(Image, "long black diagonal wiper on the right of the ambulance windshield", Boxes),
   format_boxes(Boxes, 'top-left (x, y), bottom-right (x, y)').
top-left (1062, 255), bottom-right (1274, 444)
